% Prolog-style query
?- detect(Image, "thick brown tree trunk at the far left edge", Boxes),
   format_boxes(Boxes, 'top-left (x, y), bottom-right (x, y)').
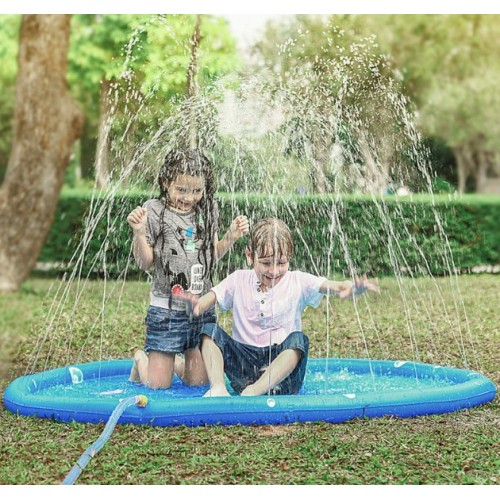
top-left (0, 14), bottom-right (83, 292)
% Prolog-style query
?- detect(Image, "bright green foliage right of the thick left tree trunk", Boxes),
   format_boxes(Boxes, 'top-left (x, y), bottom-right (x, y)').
top-left (70, 14), bottom-right (239, 180)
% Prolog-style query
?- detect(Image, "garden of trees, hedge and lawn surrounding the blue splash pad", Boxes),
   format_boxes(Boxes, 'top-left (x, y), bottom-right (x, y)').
top-left (0, 14), bottom-right (500, 485)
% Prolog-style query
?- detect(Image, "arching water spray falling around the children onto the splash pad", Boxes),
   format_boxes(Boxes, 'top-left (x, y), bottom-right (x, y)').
top-left (6, 17), bottom-right (494, 436)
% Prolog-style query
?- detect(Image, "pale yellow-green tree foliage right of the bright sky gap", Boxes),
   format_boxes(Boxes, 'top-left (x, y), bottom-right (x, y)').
top-left (252, 14), bottom-right (500, 192)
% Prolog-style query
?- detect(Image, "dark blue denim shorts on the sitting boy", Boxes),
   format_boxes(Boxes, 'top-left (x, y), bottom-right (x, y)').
top-left (200, 324), bottom-right (309, 395)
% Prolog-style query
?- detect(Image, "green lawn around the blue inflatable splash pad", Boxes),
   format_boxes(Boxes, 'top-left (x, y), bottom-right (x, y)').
top-left (0, 275), bottom-right (500, 485)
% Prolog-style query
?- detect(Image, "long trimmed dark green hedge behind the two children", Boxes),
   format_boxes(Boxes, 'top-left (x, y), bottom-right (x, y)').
top-left (40, 190), bottom-right (500, 276)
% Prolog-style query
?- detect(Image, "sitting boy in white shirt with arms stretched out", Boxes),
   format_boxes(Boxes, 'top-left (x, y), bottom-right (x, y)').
top-left (174, 218), bottom-right (378, 396)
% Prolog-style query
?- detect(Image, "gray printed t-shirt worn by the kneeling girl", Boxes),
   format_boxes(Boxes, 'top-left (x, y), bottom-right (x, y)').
top-left (144, 199), bottom-right (218, 311)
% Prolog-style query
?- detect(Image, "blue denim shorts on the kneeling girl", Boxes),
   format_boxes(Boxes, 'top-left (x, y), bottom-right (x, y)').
top-left (144, 306), bottom-right (216, 354)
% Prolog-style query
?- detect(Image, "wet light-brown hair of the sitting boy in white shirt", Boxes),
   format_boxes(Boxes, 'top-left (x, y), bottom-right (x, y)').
top-left (247, 217), bottom-right (293, 258)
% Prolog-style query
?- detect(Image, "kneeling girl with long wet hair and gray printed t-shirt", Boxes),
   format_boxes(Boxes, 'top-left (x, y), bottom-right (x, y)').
top-left (127, 149), bottom-right (248, 389)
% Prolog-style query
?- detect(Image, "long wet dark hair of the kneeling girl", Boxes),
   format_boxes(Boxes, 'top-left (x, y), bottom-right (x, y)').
top-left (158, 149), bottom-right (217, 277)
